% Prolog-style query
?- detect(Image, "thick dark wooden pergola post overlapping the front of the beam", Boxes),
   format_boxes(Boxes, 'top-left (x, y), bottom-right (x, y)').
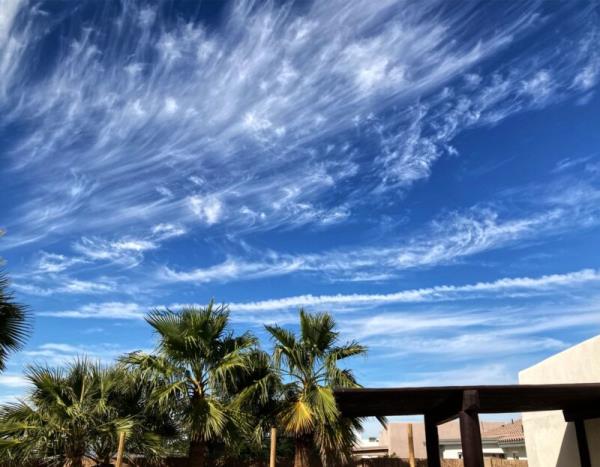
top-left (458, 390), bottom-right (484, 467)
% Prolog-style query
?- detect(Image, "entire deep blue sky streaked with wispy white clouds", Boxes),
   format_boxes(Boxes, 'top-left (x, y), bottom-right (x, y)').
top-left (0, 0), bottom-right (600, 436)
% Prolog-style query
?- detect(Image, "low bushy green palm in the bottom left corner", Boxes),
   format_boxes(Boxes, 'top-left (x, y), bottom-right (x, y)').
top-left (0, 359), bottom-right (169, 467)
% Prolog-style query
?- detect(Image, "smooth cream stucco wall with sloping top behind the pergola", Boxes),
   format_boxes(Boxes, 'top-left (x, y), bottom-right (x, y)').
top-left (519, 336), bottom-right (600, 467)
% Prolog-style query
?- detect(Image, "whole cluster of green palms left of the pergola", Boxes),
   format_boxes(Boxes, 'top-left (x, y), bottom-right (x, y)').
top-left (0, 302), bottom-right (366, 467)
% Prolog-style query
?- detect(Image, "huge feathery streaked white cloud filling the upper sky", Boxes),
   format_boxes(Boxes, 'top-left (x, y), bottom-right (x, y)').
top-left (0, 0), bottom-right (595, 253)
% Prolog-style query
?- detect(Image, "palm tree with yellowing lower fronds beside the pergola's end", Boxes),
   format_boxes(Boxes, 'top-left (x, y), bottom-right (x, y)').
top-left (265, 309), bottom-right (366, 467)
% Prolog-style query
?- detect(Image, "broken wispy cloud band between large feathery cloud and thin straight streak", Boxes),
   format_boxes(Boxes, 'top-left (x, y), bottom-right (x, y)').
top-left (17, 178), bottom-right (600, 300)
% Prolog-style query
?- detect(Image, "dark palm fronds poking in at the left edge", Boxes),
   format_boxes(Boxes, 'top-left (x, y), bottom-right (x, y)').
top-left (0, 272), bottom-right (30, 371)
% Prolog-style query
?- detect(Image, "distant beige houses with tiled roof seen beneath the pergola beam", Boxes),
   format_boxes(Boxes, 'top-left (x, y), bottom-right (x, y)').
top-left (354, 420), bottom-right (527, 460)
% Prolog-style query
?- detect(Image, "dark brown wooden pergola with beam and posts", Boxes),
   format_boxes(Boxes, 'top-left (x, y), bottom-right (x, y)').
top-left (335, 384), bottom-right (600, 467)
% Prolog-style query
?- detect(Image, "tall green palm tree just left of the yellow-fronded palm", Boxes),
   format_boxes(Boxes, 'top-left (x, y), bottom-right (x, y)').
top-left (123, 301), bottom-right (257, 467)
